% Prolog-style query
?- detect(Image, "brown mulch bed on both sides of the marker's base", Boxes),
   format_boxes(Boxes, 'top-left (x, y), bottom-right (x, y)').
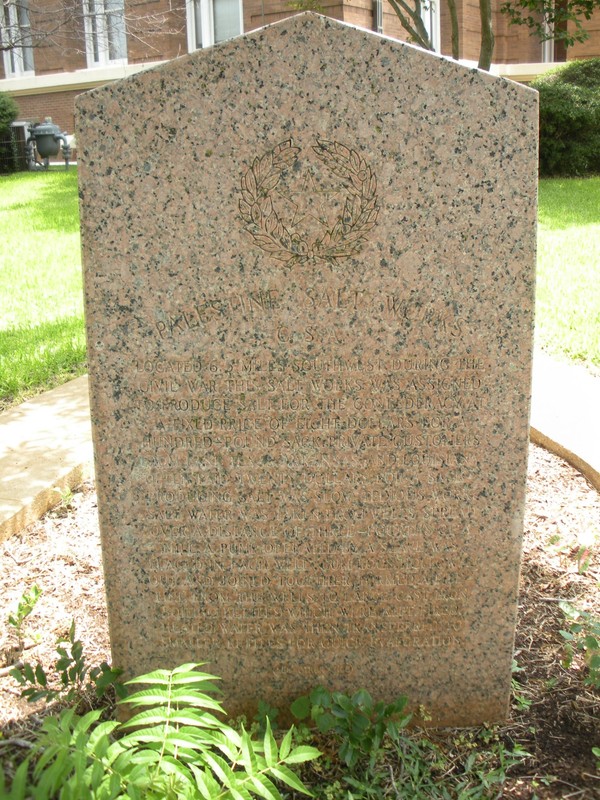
top-left (0, 445), bottom-right (600, 800)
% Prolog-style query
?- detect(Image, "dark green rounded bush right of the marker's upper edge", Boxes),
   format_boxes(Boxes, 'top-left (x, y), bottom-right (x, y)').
top-left (531, 58), bottom-right (600, 177)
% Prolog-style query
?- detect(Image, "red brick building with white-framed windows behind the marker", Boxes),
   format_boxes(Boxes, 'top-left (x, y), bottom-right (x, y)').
top-left (0, 0), bottom-right (600, 138)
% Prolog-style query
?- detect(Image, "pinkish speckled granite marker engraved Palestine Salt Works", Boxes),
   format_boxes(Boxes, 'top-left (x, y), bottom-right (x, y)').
top-left (77, 15), bottom-right (537, 725)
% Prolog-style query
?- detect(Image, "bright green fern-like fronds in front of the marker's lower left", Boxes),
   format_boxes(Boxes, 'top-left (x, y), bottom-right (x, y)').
top-left (2, 664), bottom-right (320, 800)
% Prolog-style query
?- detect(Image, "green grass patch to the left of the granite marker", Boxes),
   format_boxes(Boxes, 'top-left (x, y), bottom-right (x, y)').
top-left (0, 168), bottom-right (85, 410)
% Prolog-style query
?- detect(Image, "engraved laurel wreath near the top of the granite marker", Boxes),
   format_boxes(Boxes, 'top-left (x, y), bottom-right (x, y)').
top-left (239, 138), bottom-right (379, 265)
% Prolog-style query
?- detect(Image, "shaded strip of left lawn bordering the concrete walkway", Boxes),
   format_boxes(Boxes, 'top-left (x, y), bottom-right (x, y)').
top-left (0, 316), bottom-right (86, 407)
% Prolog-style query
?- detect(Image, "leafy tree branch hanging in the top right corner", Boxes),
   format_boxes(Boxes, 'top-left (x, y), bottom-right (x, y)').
top-left (500, 0), bottom-right (600, 47)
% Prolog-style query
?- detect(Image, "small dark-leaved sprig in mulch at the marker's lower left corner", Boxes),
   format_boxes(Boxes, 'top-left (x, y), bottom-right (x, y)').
top-left (10, 621), bottom-right (125, 703)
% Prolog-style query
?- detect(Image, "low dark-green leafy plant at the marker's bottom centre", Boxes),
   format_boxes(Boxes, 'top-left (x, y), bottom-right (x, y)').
top-left (291, 686), bottom-right (411, 769)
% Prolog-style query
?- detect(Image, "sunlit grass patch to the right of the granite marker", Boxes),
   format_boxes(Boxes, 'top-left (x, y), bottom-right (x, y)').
top-left (536, 177), bottom-right (600, 367)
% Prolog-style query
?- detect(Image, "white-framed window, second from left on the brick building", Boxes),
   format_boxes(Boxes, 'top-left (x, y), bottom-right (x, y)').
top-left (83, 0), bottom-right (127, 67)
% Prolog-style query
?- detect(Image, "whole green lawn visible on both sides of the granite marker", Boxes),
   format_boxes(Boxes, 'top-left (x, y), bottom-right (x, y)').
top-left (0, 168), bottom-right (600, 410)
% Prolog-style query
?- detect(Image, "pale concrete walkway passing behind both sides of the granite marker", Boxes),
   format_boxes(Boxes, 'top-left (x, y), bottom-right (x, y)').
top-left (0, 351), bottom-right (600, 541)
